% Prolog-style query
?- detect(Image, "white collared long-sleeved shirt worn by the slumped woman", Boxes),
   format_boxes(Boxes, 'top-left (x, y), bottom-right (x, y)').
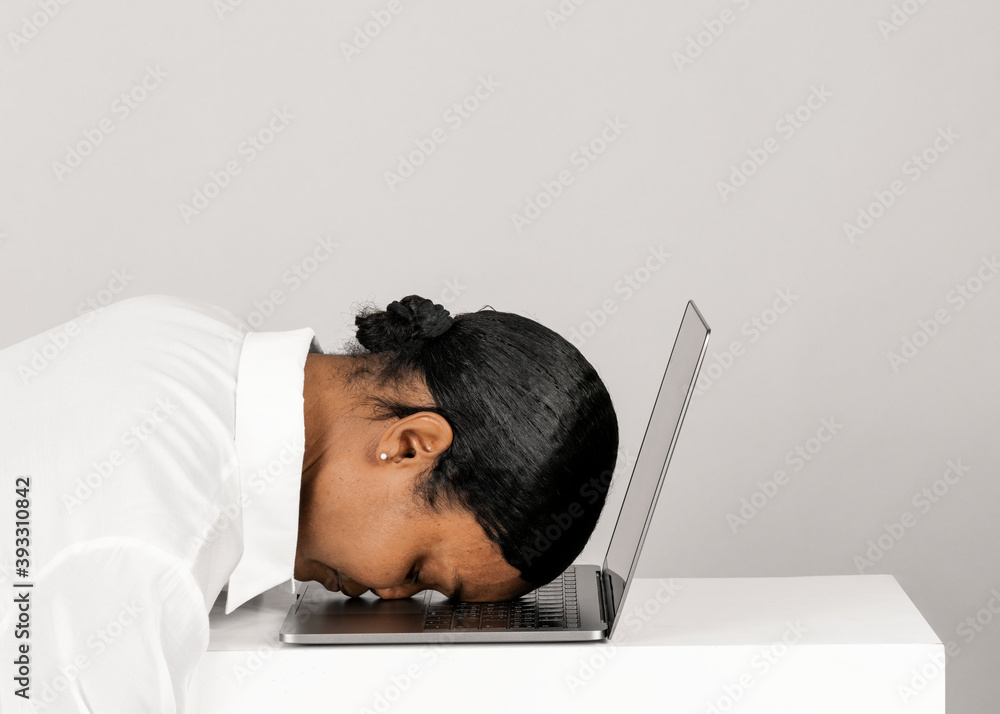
top-left (0, 296), bottom-right (318, 714)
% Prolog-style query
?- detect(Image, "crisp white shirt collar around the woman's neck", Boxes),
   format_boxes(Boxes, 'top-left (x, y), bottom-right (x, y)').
top-left (226, 327), bottom-right (315, 615)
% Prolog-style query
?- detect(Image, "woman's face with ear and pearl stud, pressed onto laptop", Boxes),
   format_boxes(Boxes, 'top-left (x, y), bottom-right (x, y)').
top-left (295, 390), bottom-right (531, 601)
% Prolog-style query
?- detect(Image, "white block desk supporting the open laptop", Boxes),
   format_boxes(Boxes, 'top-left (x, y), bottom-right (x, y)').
top-left (191, 575), bottom-right (945, 714)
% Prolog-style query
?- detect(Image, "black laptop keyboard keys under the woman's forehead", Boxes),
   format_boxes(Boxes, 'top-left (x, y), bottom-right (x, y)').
top-left (424, 570), bottom-right (580, 632)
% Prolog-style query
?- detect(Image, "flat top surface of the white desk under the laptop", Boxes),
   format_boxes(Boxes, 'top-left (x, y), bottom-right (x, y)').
top-left (208, 575), bottom-right (940, 651)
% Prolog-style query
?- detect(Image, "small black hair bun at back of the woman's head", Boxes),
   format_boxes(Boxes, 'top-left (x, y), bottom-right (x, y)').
top-left (354, 295), bottom-right (455, 352)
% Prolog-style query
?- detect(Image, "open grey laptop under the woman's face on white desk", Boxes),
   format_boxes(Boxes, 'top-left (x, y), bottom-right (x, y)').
top-left (278, 301), bottom-right (711, 644)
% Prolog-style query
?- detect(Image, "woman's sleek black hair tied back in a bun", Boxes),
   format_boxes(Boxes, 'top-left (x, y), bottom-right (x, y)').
top-left (345, 295), bottom-right (618, 587)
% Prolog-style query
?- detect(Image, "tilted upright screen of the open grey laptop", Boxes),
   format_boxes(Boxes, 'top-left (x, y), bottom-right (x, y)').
top-left (604, 302), bottom-right (711, 638)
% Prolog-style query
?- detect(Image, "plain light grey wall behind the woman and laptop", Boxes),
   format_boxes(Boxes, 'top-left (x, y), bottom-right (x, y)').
top-left (0, 0), bottom-right (1000, 714)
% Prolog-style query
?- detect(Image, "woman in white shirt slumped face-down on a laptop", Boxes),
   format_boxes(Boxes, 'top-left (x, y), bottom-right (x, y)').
top-left (0, 288), bottom-right (618, 712)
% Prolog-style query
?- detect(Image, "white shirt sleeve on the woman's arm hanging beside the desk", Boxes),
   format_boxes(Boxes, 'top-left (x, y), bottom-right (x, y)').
top-left (2, 537), bottom-right (209, 714)
